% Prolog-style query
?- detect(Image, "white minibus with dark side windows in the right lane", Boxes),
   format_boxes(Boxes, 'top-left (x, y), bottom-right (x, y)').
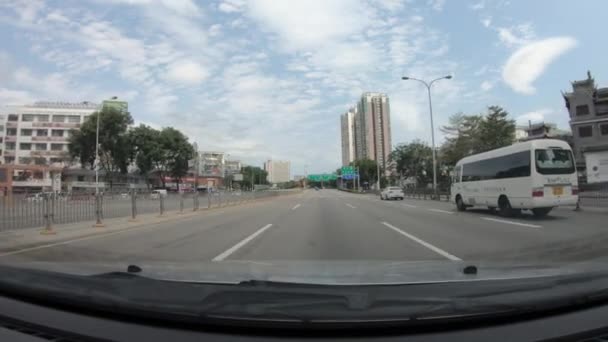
top-left (451, 139), bottom-right (578, 217)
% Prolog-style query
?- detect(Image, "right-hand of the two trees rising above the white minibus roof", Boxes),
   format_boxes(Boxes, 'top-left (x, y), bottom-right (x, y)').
top-left (476, 106), bottom-right (515, 152)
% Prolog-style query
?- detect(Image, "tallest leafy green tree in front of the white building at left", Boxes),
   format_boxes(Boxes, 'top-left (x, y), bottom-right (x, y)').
top-left (68, 107), bottom-right (133, 180)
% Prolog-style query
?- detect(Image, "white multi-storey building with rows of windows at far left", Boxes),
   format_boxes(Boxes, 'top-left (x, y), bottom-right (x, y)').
top-left (0, 102), bottom-right (99, 167)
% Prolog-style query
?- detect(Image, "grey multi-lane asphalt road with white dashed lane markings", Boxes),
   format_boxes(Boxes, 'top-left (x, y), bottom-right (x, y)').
top-left (2, 189), bottom-right (608, 263)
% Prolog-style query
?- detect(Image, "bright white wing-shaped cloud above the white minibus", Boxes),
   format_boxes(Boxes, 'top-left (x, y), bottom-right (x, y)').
top-left (502, 37), bottom-right (577, 94)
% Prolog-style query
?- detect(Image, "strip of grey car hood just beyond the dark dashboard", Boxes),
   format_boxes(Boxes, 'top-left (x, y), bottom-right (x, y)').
top-left (1, 260), bottom-right (606, 285)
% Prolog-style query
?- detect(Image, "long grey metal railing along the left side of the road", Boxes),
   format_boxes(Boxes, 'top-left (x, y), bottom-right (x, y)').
top-left (0, 190), bottom-right (302, 231)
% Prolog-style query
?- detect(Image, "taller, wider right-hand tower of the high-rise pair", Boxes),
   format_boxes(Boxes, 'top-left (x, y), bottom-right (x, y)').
top-left (342, 93), bottom-right (392, 170)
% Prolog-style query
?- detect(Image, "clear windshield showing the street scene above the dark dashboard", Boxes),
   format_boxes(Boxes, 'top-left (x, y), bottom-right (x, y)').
top-left (0, 0), bottom-right (608, 328)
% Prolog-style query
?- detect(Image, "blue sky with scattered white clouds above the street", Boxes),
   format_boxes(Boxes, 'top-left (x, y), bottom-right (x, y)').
top-left (0, 0), bottom-right (608, 174)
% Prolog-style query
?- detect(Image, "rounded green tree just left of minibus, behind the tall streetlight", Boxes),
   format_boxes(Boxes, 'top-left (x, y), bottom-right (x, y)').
top-left (390, 140), bottom-right (433, 186)
